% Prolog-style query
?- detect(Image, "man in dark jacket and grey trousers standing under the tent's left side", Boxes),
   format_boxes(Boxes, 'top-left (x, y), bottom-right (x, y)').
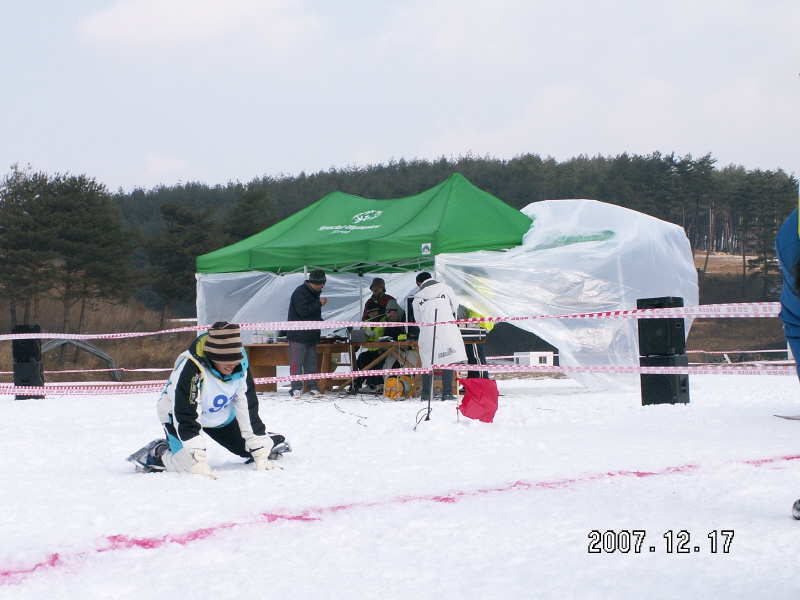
top-left (286, 269), bottom-right (328, 398)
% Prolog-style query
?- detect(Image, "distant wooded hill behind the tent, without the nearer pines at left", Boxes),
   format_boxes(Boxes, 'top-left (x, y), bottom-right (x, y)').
top-left (115, 152), bottom-right (798, 257)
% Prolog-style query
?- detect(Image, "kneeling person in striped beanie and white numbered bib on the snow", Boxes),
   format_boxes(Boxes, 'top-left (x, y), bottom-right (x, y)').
top-left (128, 321), bottom-right (291, 479)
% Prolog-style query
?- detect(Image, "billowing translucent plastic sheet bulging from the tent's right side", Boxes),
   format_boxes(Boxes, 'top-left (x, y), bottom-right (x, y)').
top-left (436, 200), bottom-right (698, 390)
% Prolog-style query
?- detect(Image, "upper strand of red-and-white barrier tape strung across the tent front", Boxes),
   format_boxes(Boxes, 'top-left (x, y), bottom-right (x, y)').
top-left (0, 302), bottom-right (781, 341)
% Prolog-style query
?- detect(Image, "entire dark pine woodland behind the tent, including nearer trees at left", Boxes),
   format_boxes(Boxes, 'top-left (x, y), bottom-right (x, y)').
top-left (0, 152), bottom-right (798, 332)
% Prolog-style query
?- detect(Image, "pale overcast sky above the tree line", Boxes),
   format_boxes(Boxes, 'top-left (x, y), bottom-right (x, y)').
top-left (0, 0), bottom-right (800, 191)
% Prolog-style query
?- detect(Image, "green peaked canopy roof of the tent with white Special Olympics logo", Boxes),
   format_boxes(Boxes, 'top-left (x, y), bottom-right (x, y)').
top-left (197, 174), bottom-right (532, 273)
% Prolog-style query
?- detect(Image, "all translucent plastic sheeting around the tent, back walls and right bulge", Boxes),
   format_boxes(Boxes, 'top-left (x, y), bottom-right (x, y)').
top-left (197, 200), bottom-right (698, 391)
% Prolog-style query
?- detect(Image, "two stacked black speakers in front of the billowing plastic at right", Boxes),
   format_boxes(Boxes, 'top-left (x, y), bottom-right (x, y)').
top-left (636, 296), bottom-right (689, 406)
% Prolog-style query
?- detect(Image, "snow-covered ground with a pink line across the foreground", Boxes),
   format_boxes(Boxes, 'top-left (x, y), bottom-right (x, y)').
top-left (0, 376), bottom-right (800, 600)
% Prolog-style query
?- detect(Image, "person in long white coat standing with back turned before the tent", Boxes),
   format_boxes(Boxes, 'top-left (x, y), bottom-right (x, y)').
top-left (413, 271), bottom-right (467, 400)
